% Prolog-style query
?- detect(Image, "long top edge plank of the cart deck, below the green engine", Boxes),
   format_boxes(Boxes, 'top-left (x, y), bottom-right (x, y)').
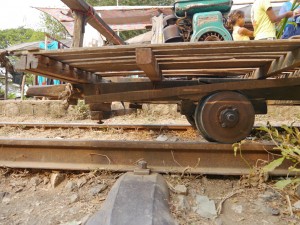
top-left (27, 40), bottom-right (300, 57)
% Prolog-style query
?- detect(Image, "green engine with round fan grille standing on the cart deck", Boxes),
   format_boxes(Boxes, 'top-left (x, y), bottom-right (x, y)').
top-left (163, 0), bottom-right (233, 43)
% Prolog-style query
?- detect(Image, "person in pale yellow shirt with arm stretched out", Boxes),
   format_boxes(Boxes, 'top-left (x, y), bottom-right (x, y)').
top-left (251, 0), bottom-right (294, 40)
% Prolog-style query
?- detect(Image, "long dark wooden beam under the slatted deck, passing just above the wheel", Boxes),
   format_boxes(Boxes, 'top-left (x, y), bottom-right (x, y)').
top-left (85, 78), bottom-right (300, 103)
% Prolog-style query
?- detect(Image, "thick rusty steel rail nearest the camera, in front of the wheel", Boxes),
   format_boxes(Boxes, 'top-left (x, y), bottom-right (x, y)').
top-left (0, 138), bottom-right (289, 175)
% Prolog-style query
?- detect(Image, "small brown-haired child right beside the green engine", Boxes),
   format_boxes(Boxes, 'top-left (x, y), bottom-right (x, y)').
top-left (227, 10), bottom-right (253, 41)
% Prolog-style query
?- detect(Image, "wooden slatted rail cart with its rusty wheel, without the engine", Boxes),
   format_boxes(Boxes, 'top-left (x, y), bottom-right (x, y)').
top-left (17, 39), bottom-right (300, 143)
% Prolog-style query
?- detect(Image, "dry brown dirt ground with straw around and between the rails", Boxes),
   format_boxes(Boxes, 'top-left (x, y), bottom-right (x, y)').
top-left (0, 105), bottom-right (300, 225)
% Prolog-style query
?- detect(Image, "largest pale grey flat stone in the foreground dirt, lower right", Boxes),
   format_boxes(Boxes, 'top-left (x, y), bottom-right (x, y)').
top-left (193, 195), bottom-right (217, 219)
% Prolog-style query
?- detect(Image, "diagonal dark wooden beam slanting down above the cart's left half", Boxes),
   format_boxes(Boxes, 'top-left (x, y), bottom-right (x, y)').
top-left (61, 0), bottom-right (125, 45)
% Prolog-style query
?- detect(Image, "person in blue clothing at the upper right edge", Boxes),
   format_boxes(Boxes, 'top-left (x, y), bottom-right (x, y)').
top-left (279, 0), bottom-right (300, 39)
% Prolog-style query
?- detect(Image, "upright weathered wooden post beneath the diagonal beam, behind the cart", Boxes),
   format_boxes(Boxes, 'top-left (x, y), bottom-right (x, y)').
top-left (72, 11), bottom-right (85, 48)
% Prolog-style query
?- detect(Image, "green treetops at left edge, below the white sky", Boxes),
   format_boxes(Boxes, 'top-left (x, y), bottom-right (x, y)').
top-left (0, 27), bottom-right (44, 49)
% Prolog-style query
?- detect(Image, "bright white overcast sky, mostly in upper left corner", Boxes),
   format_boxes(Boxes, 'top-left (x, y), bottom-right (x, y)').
top-left (0, 0), bottom-right (286, 30)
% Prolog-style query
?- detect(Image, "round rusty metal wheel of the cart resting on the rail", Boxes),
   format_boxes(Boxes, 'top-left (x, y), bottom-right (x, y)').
top-left (194, 91), bottom-right (255, 143)
